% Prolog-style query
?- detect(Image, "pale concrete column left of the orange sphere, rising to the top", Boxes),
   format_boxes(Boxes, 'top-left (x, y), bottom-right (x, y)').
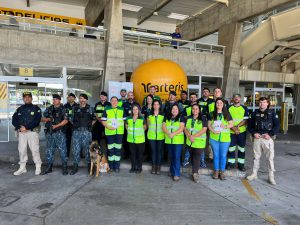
top-left (102, 0), bottom-right (125, 91)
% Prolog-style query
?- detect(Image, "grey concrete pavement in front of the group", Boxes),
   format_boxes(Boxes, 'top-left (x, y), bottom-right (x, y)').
top-left (0, 138), bottom-right (300, 225)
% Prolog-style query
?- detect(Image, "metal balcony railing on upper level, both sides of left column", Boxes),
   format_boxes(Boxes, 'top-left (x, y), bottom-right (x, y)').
top-left (0, 14), bottom-right (225, 55)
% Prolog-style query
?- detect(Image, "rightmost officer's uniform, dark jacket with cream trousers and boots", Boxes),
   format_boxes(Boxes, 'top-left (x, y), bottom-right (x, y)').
top-left (247, 105), bottom-right (279, 185)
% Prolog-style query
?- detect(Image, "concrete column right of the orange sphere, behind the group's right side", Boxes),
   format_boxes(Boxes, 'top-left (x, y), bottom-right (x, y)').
top-left (219, 23), bottom-right (242, 99)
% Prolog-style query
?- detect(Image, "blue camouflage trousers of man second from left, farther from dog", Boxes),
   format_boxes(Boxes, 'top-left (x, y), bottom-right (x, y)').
top-left (46, 131), bottom-right (68, 165)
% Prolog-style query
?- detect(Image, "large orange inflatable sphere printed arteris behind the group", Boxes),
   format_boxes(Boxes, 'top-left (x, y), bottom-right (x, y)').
top-left (130, 59), bottom-right (187, 104)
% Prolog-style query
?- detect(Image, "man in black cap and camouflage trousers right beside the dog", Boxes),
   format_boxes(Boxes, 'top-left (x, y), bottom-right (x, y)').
top-left (70, 94), bottom-right (95, 175)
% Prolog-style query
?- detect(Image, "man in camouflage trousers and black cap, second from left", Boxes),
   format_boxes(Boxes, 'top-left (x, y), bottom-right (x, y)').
top-left (42, 94), bottom-right (68, 175)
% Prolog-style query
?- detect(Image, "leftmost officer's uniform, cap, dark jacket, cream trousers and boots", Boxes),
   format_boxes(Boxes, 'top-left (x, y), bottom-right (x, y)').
top-left (12, 92), bottom-right (42, 176)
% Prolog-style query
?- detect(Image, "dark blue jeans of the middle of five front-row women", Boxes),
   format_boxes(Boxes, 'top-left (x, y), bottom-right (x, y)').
top-left (167, 144), bottom-right (183, 177)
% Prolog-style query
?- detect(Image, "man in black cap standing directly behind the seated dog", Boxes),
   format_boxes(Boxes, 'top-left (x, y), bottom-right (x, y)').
top-left (92, 91), bottom-right (111, 144)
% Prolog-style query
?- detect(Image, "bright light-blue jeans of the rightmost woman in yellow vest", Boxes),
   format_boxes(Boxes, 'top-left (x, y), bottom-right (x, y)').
top-left (209, 139), bottom-right (230, 171)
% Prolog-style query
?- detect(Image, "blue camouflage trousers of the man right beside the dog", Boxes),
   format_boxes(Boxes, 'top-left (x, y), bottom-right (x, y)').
top-left (72, 130), bottom-right (92, 164)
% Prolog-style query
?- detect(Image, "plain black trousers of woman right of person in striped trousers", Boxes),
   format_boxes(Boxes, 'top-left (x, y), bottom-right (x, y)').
top-left (128, 143), bottom-right (145, 169)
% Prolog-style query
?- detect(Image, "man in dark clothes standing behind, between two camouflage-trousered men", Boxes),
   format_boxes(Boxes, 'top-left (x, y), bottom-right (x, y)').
top-left (64, 93), bottom-right (78, 157)
